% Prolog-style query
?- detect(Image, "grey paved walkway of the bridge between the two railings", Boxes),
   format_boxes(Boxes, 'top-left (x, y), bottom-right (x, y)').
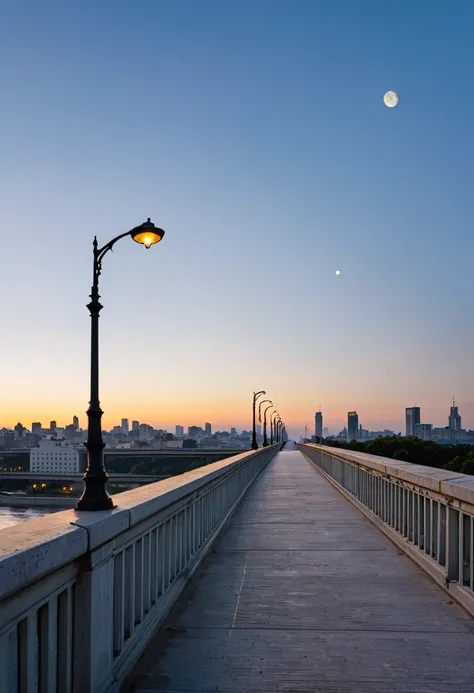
top-left (128, 452), bottom-right (474, 693)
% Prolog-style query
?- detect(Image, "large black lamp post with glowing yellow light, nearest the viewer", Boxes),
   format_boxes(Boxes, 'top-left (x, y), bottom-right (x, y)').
top-left (77, 219), bottom-right (165, 510)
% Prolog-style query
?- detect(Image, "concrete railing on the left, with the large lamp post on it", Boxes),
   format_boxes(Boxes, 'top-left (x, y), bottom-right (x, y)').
top-left (0, 445), bottom-right (280, 693)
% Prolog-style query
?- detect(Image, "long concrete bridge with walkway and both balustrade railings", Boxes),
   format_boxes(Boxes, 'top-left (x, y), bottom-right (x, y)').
top-left (0, 445), bottom-right (474, 693)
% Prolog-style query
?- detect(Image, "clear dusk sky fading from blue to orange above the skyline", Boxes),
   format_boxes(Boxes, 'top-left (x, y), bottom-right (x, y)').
top-left (0, 0), bottom-right (474, 435)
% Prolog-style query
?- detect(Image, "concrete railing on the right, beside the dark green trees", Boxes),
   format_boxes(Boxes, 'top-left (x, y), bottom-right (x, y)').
top-left (298, 444), bottom-right (474, 615)
